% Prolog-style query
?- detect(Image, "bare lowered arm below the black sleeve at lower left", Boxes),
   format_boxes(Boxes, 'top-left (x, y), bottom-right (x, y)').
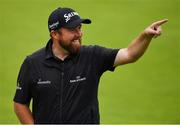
top-left (14, 102), bottom-right (34, 124)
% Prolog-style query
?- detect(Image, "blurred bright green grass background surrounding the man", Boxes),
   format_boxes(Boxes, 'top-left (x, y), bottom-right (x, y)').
top-left (0, 0), bottom-right (180, 124)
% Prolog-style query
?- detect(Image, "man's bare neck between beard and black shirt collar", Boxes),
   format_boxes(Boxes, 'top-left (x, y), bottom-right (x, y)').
top-left (52, 41), bottom-right (69, 60)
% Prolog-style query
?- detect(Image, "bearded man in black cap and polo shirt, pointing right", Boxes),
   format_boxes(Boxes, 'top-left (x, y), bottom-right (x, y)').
top-left (14, 8), bottom-right (167, 124)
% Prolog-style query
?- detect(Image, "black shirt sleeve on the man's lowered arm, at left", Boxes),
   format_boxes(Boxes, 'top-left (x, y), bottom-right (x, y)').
top-left (14, 57), bottom-right (32, 104)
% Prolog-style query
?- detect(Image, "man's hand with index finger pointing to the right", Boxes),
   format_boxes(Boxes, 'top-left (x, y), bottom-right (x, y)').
top-left (144, 19), bottom-right (168, 38)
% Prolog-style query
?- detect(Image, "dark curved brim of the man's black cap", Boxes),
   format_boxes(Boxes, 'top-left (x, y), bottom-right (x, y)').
top-left (63, 19), bottom-right (91, 28)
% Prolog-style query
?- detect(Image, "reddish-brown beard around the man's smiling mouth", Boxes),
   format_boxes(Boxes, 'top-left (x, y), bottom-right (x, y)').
top-left (59, 38), bottom-right (81, 54)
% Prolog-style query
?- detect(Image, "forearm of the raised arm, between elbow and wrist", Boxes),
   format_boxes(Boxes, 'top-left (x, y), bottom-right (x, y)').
top-left (127, 32), bottom-right (153, 61)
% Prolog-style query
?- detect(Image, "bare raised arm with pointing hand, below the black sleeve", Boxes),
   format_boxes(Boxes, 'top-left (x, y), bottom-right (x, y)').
top-left (114, 19), bottom-right (168, 66)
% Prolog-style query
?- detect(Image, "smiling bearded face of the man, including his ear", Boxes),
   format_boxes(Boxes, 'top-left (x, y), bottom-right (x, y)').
top-left (51, 25), bottom-right (82, 54)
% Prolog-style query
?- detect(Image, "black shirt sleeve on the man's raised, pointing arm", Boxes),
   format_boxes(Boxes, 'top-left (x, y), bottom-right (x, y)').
top-left (93, 45), bottom-right (119, 73)
